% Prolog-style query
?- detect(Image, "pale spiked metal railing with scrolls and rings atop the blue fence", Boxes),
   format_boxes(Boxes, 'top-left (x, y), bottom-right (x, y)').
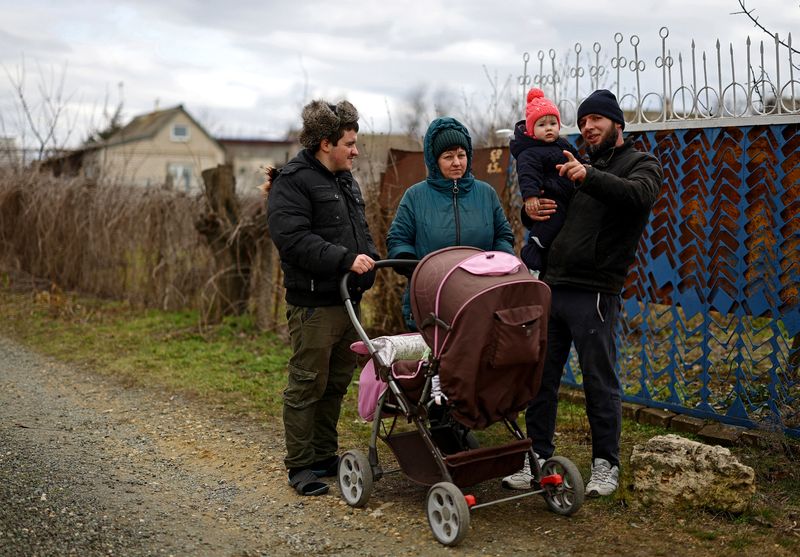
top-left (519, 27), bottom-right (800, 128)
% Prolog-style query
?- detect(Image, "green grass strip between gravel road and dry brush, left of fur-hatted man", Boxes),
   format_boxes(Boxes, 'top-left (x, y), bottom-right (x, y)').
top-left (0, 292), bottom-right (290, 416)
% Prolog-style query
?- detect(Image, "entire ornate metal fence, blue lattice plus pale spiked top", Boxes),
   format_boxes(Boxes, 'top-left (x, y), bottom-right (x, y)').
top-left (520, 28), bottom-right (800, 437)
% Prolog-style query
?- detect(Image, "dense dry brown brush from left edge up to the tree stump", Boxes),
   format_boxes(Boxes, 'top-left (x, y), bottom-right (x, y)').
top-left (0, 173), bottom-right (213, 309)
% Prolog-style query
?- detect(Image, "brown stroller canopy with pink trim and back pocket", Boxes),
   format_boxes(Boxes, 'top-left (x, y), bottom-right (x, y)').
top-left (411, 247), bottom-right (550, 429)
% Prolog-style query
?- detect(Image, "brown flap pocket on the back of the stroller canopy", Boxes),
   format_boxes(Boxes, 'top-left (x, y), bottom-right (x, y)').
top-left (489, 305), bottom-right (544, 367)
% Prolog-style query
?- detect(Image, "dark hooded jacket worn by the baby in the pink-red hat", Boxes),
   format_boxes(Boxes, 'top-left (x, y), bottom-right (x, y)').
top-left (509, 120), bottom-right (581, 203)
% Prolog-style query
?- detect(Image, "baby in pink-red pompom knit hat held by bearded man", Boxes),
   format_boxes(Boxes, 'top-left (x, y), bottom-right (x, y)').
top-left (510, 87), bottom-right (580, 276)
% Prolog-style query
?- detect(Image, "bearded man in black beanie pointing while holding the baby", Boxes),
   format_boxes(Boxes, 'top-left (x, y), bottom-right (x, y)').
top-left (509, 89), bottom-right (663, 497)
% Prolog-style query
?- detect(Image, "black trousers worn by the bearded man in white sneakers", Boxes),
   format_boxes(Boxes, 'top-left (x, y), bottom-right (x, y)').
top-left (525, 286), bottom-right (622, 465)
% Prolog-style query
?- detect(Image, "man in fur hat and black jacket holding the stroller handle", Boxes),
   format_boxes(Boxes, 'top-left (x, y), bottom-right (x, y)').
top-left (267, 100), bottom-right (378, 495)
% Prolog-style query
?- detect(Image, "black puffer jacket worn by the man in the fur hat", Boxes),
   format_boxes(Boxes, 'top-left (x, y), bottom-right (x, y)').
top-left (267, 149), bottom-right (378, 307)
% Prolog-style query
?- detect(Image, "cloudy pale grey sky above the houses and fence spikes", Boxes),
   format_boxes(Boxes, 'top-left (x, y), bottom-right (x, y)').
top-left (0, 0), bottom-right (800, 148)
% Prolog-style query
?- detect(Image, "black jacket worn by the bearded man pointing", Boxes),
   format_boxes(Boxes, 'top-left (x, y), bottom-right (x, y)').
top-left (544, 140), bottom-right (664, 294)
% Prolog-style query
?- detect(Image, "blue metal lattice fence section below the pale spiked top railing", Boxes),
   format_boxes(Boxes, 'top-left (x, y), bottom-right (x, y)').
top-left (564, 123), bottom-right (800, 436)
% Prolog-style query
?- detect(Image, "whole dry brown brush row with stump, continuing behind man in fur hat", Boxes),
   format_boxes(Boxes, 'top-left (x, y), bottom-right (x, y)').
top-left (0, 166), bottom-right (405, 333)
